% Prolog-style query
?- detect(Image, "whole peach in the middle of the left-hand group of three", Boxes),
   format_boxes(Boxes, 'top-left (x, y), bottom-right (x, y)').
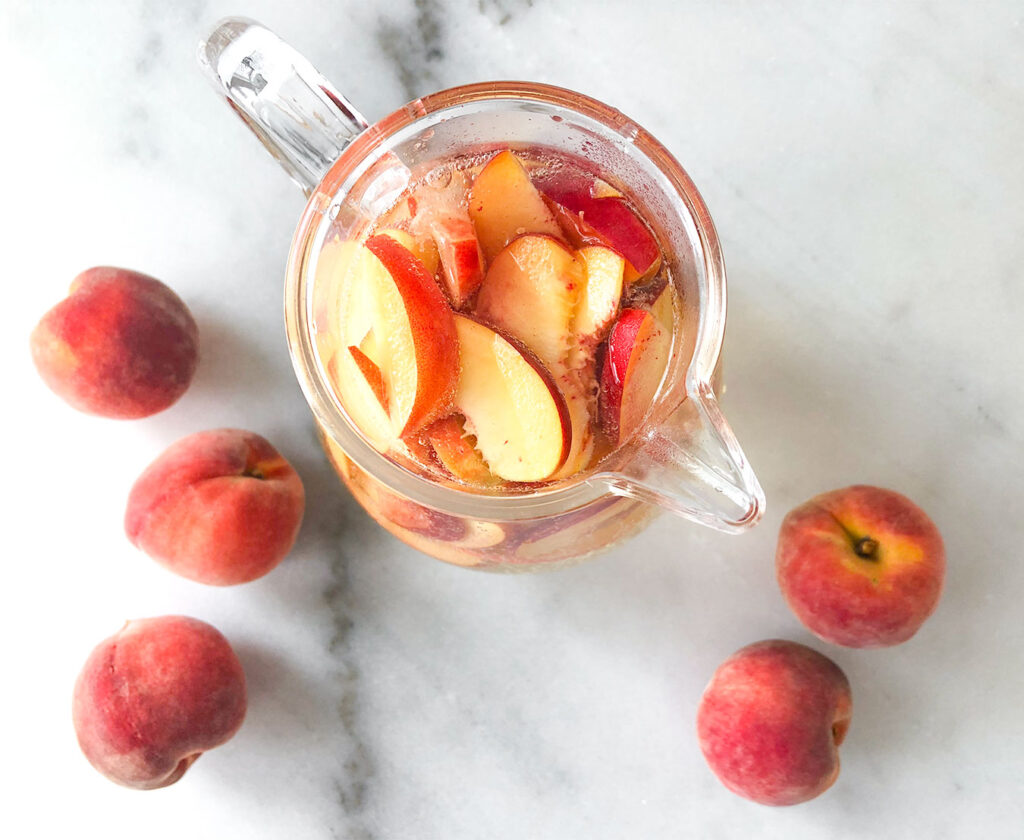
top-left (125, 429), bottom-right (305, 586)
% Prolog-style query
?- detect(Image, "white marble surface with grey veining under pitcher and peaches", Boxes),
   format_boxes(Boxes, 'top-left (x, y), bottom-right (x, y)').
top-left (0, 0), bottom-right (1024, 840)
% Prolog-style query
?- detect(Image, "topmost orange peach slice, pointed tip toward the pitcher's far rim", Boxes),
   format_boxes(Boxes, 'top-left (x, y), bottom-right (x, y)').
top-left (469, 151), bottom-right (561, 261)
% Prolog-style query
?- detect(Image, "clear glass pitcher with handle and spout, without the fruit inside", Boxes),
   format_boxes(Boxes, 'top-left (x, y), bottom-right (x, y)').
top-left (199, 17), bottom-right (764, 572)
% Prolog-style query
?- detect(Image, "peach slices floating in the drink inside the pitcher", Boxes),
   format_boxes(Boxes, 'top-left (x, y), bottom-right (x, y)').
top-left (314, 150), bottom-right (681, 564)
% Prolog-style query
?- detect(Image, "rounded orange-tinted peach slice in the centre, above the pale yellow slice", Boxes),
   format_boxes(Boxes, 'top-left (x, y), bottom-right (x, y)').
top-left (475, 234), bottom-right (584, 367)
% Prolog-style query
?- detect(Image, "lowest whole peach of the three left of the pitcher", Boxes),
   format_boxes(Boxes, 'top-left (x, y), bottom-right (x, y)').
top-left (72, 616), bottom-right (246, 790)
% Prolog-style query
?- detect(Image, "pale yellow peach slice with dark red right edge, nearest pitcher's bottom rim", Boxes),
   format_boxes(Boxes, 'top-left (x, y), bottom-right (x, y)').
top-left (455, 314), bottom-right (571, 481)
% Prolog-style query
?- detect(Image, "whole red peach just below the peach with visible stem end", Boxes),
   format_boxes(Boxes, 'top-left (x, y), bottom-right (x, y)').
top-left (697, 639), bottom-right (853, 805)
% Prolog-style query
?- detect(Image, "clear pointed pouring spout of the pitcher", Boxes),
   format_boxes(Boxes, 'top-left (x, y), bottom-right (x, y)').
top-left (595, 382), bottom-right (765, 534)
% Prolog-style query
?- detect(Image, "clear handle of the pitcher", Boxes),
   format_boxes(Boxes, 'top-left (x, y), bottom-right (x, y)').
top-left (198, 17), bottom-right (368, 196)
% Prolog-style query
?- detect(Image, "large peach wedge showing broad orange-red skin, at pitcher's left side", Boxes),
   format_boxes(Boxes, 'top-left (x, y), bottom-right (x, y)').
top-left (338, 235), bottom-right (459, 437)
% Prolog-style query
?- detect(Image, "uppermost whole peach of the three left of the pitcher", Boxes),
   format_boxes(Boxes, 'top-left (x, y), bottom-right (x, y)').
top-left (30, 266), bottom-right (199, 420)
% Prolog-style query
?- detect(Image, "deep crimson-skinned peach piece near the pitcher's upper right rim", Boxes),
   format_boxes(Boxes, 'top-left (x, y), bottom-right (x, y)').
top-left (539, 170), bottom-right (662, 284)
